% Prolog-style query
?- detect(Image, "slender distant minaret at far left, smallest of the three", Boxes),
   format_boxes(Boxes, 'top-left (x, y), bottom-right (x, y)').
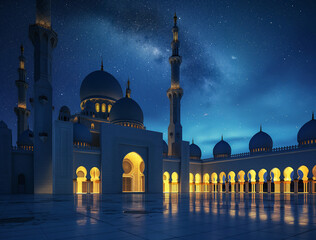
top-left (14, 45), bottom-right (30, 142)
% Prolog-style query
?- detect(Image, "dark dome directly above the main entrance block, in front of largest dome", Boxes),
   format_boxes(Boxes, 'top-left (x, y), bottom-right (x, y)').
top-left (110, 97), bottom-right (144, 126)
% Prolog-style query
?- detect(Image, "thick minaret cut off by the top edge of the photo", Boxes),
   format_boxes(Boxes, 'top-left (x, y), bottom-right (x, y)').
top-left (29, 0), bottom-right (57, 194)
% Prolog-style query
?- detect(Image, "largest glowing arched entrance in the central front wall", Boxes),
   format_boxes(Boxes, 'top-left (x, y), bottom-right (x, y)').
top-left (122, 152), bottom-right (145, 192)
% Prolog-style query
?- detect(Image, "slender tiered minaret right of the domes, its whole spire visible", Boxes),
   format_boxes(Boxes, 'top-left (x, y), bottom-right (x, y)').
top-left (167, 14), bottom-right (183, 157)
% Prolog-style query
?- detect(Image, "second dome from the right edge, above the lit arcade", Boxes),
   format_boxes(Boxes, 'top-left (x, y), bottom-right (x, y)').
top-left (249, 127), bottom-right (273, 152)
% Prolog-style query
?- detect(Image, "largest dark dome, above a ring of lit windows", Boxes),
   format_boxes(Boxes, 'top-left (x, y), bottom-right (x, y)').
top-left (80, 70), bottom-right (123, 101)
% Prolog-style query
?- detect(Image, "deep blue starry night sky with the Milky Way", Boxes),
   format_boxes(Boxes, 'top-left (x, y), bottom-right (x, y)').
top-left (0, 0), bottom-right (316, 158)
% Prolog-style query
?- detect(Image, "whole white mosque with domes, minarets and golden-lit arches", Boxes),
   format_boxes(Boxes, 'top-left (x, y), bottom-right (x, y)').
top-left (0, 0), bottom-right (316, 194)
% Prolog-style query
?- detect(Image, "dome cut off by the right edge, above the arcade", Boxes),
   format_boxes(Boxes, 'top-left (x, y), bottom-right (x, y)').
top-left (297, 113), bottom-right (316, 145)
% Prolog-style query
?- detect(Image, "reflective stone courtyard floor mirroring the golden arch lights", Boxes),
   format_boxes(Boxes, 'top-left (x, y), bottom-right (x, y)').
top-left (0, 193), bottom-right (316, 240)
